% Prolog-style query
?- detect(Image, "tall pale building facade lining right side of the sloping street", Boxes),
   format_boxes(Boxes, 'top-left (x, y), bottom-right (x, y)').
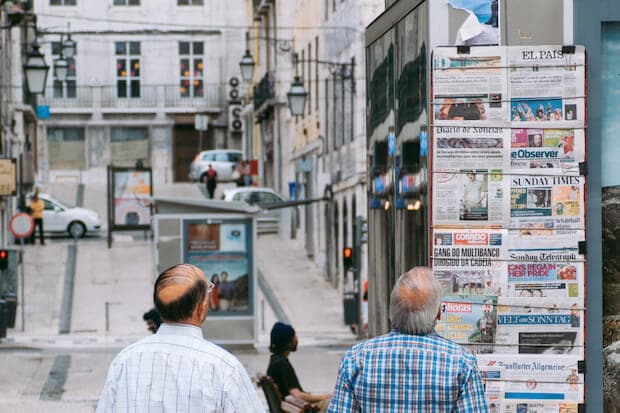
top-left (245, 0), bottom-right (384, 290)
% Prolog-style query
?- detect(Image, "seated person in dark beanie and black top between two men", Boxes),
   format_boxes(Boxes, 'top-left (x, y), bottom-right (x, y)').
top-left (267, 322), bottom-right (331, 413)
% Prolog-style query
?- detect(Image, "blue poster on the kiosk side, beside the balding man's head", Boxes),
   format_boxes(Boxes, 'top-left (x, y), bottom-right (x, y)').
top-left (184, 220), bottom-right (252, 315)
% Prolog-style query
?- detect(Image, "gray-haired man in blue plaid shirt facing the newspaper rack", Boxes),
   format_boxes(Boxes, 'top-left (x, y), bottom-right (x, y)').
top-left (327, 267), bottom-right (488, 413)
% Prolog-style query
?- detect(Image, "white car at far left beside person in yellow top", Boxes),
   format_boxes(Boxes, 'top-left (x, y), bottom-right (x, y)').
top-left (29, 193), bottom-right (101, 238)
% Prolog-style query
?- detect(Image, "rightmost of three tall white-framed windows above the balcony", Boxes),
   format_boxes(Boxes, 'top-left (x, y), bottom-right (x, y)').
top-left (179, 42), bottom-right (204, 98)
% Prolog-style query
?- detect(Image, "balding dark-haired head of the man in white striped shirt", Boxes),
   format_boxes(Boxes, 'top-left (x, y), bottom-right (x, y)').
top-left (153, 264), bottom-right (207, 322)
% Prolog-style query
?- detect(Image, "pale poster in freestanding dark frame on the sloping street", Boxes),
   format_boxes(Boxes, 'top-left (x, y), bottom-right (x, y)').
top-left (112, 169), bottom-right (152, 227)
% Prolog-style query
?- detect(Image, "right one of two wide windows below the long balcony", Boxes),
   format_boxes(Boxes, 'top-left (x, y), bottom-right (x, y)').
top-left (110, 127), bottom-right (150, 166)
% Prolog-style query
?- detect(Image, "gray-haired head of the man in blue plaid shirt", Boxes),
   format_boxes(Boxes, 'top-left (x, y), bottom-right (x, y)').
top-left (390, 267), bottom-right (441, 334)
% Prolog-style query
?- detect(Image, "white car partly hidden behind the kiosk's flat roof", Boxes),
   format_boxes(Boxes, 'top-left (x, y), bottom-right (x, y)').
top-left (222, 186), bottom-right (286, 233)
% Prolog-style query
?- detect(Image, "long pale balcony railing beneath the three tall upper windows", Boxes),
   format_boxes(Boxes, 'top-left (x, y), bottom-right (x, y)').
top-left (39, 85), bottom-right (225, 111)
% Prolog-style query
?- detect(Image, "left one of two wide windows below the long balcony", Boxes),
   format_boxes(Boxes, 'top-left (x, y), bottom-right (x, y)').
top-left (47, 128), bottom-right (86, 169)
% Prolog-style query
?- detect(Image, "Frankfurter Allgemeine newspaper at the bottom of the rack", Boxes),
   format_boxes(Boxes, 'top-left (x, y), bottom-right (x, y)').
top-left (477, 354), bottom-right (584, 402)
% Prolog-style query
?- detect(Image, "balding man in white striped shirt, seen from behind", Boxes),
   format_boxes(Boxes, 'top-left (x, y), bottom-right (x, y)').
top-left (97, 264), bottom-right (264, 413)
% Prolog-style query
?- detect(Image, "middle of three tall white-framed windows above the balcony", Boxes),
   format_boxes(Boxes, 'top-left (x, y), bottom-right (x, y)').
top-left (116, 42), bottom-right (140, 98)
